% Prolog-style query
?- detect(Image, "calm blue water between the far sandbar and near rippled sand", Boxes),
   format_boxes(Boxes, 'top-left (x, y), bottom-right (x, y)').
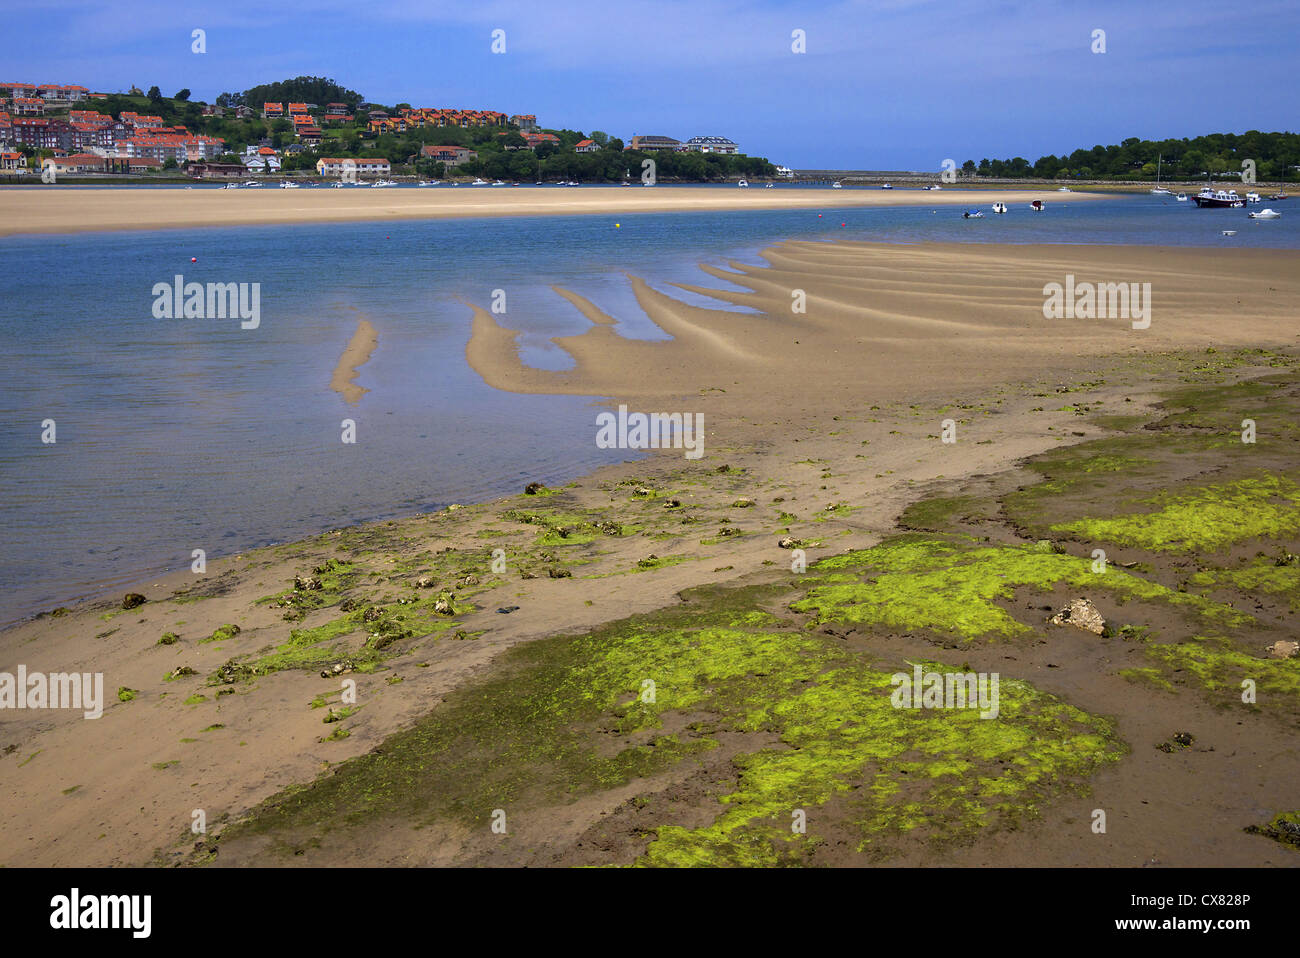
top-left (0, 187), bottom-right (1300, 621)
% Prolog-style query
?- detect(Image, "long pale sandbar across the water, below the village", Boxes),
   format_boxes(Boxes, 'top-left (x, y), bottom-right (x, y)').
top-left (0, 185), bottom-right (1105, 235)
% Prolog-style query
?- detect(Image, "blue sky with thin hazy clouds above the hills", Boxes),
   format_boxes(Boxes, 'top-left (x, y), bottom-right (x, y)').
top-left (10, 0), bottom-right (1300, 170)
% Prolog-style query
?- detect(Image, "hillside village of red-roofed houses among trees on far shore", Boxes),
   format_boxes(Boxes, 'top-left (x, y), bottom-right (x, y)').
top-left (0, 82), bottom-right (770, 181)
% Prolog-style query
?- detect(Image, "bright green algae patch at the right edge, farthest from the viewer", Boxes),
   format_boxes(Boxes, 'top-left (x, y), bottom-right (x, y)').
top-left (1052, 474), bottom-right (1300, 552)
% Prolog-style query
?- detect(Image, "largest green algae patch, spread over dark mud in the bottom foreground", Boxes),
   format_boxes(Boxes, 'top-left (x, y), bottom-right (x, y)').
top-left (210, 586), bottom-right (1122, 864)
